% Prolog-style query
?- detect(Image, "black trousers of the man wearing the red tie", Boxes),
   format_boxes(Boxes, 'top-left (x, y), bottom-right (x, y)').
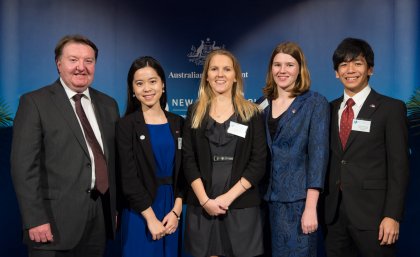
top-left (325, 195), bottom-right (396, 257)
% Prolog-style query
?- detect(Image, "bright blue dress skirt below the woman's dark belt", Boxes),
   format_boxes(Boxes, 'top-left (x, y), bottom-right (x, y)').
top-left (121, 185), bottom-right (182, 257)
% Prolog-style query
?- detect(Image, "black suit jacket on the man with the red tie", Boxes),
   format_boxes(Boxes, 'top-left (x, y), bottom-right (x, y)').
top-left (325, 89), bottom-right (409, 230)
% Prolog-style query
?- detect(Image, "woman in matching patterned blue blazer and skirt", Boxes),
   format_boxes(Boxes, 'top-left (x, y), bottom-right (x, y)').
top-left (260, 42), bottom-right (329, 256)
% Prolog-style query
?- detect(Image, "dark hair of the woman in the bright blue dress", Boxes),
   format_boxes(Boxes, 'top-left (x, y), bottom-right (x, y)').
top-left (124, 56), bottom-right (168, 116)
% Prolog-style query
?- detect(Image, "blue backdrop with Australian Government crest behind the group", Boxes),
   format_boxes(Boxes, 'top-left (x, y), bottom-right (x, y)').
top-left (0, 0), bottom-right (420, 256)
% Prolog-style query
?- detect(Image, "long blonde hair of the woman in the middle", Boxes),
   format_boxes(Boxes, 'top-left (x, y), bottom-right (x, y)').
top-left (191, 49), bottom-right (259, 128)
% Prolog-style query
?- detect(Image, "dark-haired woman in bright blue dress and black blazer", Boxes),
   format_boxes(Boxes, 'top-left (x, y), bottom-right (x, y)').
top-left (116, 56), bottom-right (183, 257)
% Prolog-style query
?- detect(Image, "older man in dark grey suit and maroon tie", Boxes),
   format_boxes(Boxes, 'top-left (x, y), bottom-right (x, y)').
top-left (11, 35), bottom-right (119, 257)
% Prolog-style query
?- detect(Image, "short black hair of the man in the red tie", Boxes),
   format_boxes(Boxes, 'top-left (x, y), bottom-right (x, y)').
top-left (332, 37), bottom-right (375, 71)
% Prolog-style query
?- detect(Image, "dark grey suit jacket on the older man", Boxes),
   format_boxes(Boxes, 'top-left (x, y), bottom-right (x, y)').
top-left (11, 80), bottom-right (119, 250)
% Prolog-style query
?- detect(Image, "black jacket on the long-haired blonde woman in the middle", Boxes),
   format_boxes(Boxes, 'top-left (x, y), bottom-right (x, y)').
top-left (182, 105), bottom-right (267, 208)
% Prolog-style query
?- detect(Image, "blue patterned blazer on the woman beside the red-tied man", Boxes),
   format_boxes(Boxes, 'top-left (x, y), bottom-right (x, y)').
top-left (264, 91), bottom-right (330, 202)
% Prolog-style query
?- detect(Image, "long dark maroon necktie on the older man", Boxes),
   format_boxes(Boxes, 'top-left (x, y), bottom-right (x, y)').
top-left (73, 94), bottom-right (108, 194)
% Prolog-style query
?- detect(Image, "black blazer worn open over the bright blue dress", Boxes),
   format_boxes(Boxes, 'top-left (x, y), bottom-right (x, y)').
top-left (117, 111), bottom-right (185, 213)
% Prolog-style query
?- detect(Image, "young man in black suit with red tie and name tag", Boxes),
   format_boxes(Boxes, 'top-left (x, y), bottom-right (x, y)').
top-left (324, 38), bottom-right (409, 257)
